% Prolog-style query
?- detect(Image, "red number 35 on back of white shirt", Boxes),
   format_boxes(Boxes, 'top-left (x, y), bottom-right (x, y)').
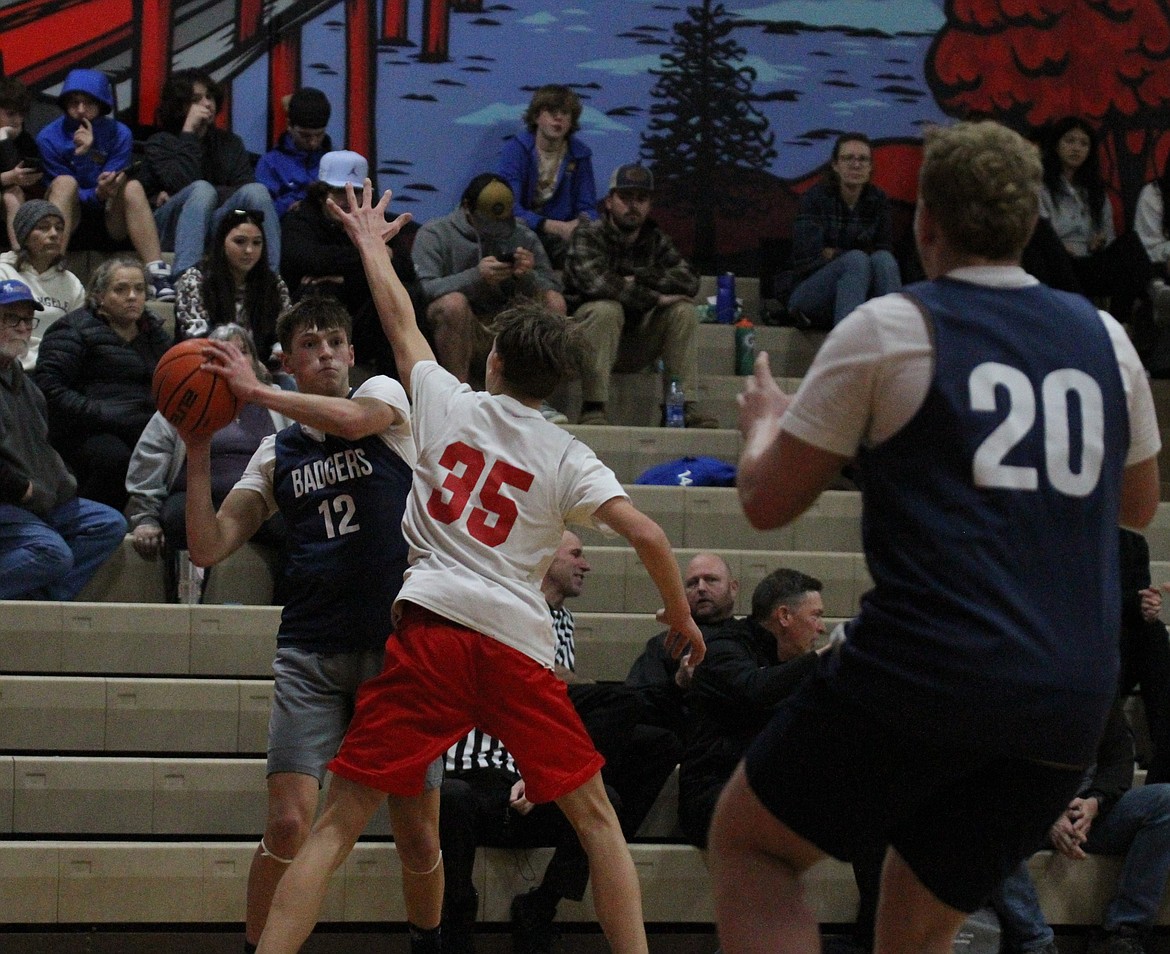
top-left (427, 440), bottom-right (532, 547)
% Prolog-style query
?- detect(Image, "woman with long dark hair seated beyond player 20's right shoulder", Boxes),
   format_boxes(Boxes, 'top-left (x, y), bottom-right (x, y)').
top-left (1040, 116), bottom-right (1151, 332)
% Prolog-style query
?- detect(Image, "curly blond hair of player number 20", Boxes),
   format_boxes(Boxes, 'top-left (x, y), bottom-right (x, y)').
top-left (918, 122), bottom-right (1042, 261)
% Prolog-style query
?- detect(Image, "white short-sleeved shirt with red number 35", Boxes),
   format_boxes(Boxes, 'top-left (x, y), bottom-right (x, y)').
top-left (399, 362), bottom-right (626, 668)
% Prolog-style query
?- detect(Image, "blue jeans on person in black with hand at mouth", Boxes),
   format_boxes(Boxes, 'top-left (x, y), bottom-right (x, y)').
top-left (154, 179), bottom-right (281, 279)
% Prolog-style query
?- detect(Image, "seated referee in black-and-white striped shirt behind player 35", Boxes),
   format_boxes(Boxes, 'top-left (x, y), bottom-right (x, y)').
top-left (439, 530), bottom-right (620, 954)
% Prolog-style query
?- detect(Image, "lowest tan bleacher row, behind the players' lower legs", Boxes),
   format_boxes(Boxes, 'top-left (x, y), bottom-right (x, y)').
top-left (0, 839), bottom-right (1151, 926)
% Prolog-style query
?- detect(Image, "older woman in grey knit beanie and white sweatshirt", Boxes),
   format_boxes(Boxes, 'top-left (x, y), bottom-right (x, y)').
top-left (0, 199), bottom-right (85, 371)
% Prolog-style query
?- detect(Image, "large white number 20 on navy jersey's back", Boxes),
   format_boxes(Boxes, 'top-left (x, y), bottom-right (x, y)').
top-left (968, 362), bottom-right (1104, 496)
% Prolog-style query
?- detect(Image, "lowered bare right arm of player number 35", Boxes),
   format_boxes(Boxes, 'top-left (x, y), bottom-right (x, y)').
top-left (594, 497), bottom-right (707, 667)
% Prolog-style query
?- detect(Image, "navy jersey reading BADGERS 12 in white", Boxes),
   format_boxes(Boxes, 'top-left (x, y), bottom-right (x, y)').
top-left (273, 424), bottom-right (412, 652)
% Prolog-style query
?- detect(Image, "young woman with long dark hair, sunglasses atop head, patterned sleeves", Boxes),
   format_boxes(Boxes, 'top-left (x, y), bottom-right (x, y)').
top-left (174, 208), bottom-right (291, 362)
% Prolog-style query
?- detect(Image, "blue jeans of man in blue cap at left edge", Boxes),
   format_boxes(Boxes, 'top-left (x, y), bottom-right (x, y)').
top-left (0, 497), bottom-right (126, 599)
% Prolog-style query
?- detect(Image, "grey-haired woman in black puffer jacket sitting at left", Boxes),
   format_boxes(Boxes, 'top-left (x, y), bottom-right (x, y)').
top-left (35, 255), bottom-right (171, 510)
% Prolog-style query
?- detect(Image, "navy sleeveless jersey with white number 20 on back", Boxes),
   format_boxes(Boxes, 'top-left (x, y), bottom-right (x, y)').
top-left (834, 279), bottom-right (1129, 764)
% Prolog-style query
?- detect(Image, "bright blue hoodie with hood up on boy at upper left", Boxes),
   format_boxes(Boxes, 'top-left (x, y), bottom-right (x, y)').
top-left (36, 69), bottom-right (133, 207)
